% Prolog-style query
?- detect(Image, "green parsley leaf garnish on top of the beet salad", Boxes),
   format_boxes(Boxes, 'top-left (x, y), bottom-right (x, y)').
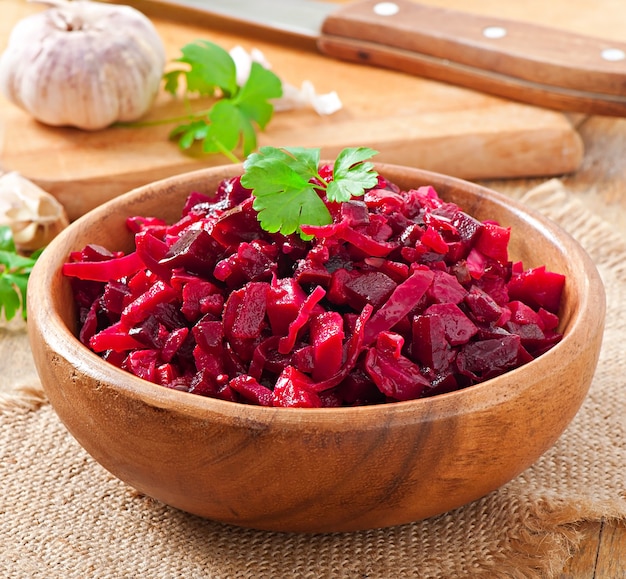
top-left (241, 147), bottom-right (378, 239)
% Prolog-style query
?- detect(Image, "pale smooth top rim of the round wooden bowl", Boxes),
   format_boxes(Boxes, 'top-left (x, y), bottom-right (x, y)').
top-left (27, 161), bottom-right (606, 430)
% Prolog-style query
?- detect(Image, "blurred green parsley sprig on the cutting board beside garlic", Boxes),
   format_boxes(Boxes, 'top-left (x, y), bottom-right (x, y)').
top-left (136, 40), bottom-right (282, 162)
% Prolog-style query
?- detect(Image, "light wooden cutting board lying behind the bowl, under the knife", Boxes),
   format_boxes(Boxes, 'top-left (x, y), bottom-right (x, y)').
top-left (0, 0), bottom-right (604, 219)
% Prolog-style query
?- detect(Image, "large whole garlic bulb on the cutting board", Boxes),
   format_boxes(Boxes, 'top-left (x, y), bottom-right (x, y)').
top-left (0, 0), bottom-right (166, 130)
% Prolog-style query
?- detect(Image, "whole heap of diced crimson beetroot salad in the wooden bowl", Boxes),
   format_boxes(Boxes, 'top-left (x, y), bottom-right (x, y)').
top-left (63, 172), bottom-right (564, 408)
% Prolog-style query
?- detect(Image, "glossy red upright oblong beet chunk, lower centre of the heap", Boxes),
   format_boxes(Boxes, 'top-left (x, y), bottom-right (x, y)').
top-left (310, 312), bottom-right (344, 382)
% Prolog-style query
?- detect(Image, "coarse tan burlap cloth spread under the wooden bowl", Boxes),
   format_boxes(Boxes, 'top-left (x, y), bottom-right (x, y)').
top-left (0, 182), bottom-right (626, 579)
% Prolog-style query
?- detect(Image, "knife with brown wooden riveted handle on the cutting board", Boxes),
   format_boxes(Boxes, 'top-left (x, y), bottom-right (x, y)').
top-left (147, 0), bottom-right (626, 116)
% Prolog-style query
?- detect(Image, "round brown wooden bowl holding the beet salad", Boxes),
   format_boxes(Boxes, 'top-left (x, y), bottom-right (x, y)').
top-left (28, 165), bottom-right (605, 532)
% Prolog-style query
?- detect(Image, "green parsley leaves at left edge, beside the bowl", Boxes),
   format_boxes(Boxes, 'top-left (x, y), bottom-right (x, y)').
top-left (0, 225), bottom-right (43, 321)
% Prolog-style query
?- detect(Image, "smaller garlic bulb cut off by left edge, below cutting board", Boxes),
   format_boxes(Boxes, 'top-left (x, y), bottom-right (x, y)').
top-left (0, 171), bottom-right (68, 252)
